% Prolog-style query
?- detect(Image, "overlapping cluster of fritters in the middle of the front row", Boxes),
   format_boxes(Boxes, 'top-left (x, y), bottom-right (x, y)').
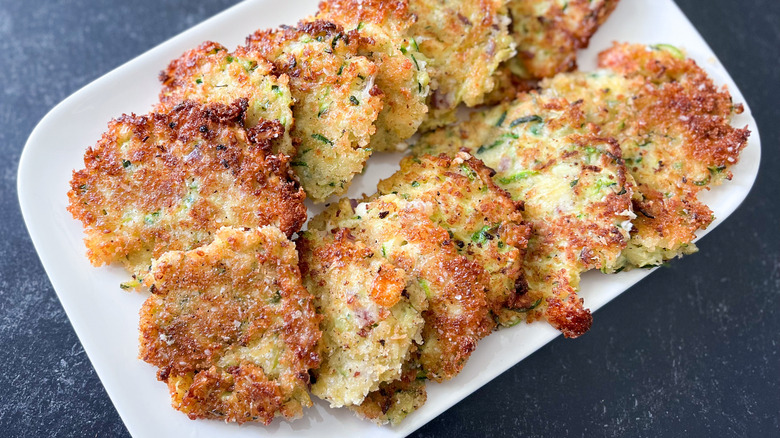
top-left (299, 154), bottom-right (529, 422)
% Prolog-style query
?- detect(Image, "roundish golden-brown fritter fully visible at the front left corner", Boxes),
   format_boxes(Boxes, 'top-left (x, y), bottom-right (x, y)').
top-left (140, 227), bottom-right (321, 425)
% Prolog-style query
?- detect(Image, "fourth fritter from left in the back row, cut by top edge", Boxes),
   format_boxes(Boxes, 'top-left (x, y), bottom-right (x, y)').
top-left (316, 0), bottom-right (430, 151)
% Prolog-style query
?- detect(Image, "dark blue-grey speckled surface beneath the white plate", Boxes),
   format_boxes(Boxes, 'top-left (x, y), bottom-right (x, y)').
top-left (0, 0), bottom-right (780, 437)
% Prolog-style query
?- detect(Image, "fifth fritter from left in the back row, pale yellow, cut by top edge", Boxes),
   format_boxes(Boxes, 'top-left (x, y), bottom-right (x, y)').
top-left (408, 0), bottom-right (515, 129)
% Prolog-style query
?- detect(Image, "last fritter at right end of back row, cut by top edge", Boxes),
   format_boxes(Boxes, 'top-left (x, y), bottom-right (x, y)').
top-left (508, 0), bottom-right (618, 79)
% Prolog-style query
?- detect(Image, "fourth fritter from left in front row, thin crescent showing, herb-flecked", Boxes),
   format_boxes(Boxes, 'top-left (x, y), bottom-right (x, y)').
top-left (377, 153), bottom-right (531, 316)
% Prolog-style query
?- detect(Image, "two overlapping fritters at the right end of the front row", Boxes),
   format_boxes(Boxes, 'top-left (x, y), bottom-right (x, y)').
top-left (416, 44), bottom-right (748, 336)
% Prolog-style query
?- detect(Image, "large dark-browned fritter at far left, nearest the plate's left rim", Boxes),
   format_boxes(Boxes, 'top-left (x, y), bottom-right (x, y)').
top-left (68, 100), bottom-right (306, 274)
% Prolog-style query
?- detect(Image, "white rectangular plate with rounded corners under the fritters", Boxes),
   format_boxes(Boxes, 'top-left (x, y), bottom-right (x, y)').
top-left (18, 0), bottom-right (761, 438)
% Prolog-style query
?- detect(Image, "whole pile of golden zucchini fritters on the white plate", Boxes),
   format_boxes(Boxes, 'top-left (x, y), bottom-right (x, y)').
top-left (68, 0), bottom-right (749, 424)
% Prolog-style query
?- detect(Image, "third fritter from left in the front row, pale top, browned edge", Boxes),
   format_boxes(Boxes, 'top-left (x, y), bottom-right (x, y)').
top-left (318, 194), bottom-right (495, 380)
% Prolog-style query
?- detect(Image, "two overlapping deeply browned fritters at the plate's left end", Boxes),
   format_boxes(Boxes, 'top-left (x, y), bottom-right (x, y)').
top-left (68, 97), bottom-right (321, 424)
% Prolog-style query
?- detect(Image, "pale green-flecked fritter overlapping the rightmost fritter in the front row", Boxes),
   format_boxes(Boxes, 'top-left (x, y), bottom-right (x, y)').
top-left (414, 94), bottom-right (634, 337)
